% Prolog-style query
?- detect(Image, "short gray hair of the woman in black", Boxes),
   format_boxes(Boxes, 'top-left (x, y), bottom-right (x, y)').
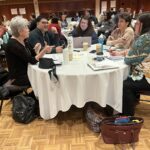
top-left (10, 16), bottom-right (29, 37)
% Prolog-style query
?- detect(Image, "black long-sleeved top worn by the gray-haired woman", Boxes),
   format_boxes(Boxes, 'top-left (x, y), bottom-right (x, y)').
top-left (6, 39), bottom-right (37, 86)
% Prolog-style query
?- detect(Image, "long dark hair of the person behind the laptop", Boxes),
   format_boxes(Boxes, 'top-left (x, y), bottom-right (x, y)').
top-left (77, 16), bottom-right (94, 36)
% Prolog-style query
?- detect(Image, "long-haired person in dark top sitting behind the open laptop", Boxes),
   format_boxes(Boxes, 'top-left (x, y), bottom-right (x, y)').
top-left (72, 16), bottom-right (98, 44)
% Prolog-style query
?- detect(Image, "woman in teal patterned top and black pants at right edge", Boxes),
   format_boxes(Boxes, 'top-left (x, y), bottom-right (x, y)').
top-left (123, 13), bottom-right (150, 116)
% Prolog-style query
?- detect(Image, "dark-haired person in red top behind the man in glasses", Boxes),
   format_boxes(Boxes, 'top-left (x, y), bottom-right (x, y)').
top-left (48, 17), bottom-right (61, 35)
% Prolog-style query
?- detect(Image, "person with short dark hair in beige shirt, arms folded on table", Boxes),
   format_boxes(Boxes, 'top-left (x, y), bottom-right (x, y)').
top-left (106, 13), bottom-right (134, 49)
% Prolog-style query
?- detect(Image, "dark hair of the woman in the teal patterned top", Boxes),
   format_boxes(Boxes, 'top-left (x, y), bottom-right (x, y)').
top-left (138, 12), bottom-right (150, 35)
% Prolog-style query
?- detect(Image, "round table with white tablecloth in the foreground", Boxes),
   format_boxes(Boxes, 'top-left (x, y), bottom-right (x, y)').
top-left (28, 45), bottom-right (129, 120)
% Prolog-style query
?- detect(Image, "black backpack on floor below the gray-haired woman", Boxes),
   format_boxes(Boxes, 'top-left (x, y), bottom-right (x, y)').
top-left (12, 95), bottom-right (37, 124)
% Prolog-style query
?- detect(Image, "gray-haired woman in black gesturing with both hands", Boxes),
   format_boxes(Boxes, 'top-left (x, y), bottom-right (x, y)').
top-left (6, 16), bottom-right (52, 86)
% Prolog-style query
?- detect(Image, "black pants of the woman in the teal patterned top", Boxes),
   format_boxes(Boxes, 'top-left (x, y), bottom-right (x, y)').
top-left (123, 78), bottom-right (150, 116)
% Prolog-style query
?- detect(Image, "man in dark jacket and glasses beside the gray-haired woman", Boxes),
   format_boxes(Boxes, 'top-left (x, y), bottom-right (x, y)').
top-left (28, 16), bottom-right (62, 53)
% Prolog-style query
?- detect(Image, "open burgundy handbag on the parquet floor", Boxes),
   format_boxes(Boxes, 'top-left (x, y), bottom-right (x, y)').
top-left (100, 117), bottom-right (144, 144)
